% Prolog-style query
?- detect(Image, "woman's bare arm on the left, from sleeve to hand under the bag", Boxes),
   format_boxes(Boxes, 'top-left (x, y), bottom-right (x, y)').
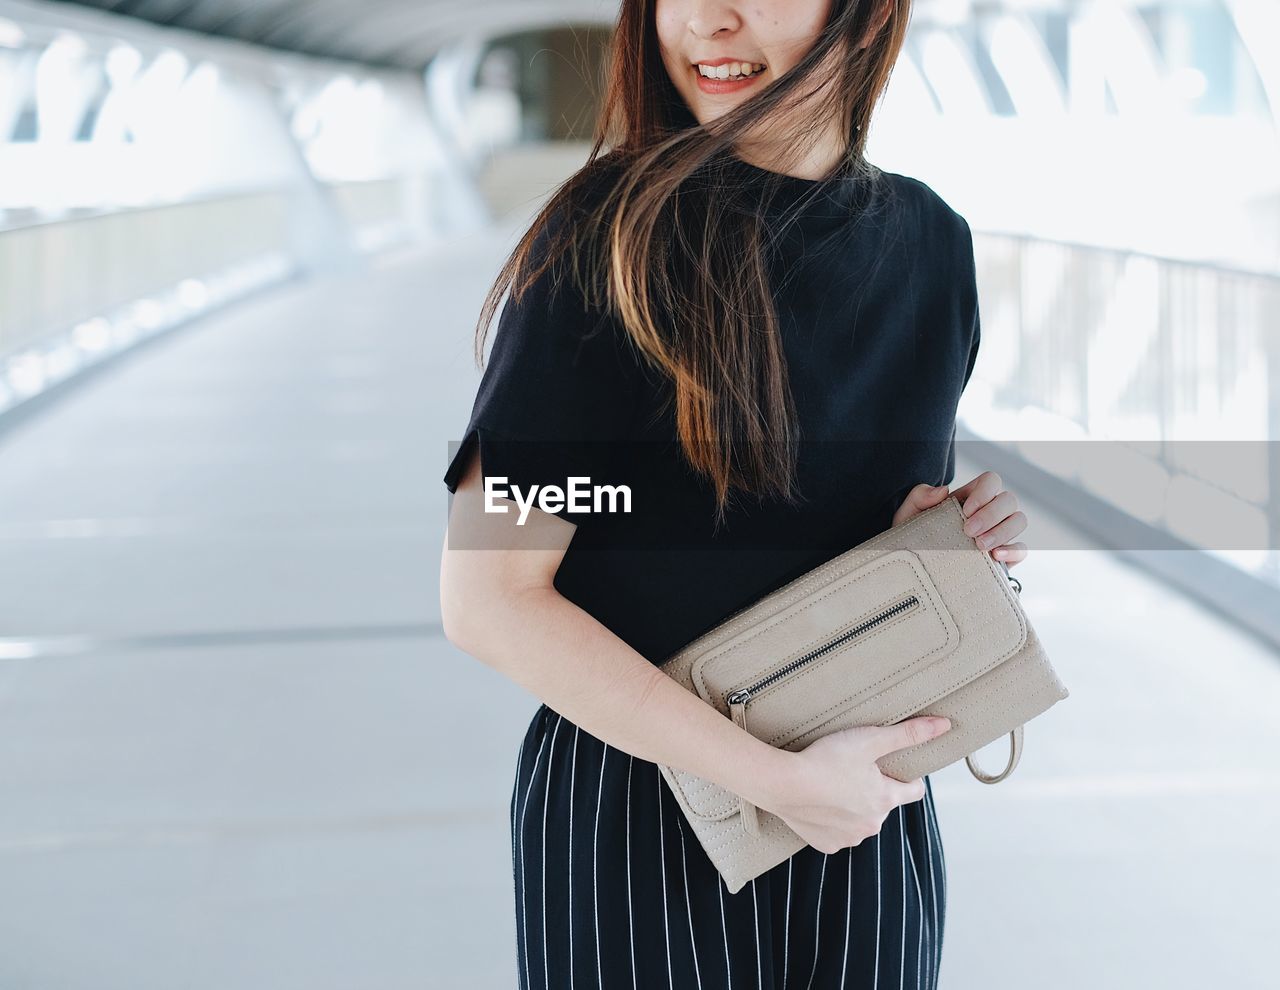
top-left (440, 452), bottom-right (950, 853)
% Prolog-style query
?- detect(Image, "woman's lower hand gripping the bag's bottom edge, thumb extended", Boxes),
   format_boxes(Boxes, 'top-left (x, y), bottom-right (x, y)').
top-left (760, 715), bottom-right (951, 853)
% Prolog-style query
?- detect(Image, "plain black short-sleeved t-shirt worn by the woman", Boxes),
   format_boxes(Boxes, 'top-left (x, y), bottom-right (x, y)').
top-left (444, 159), bottom-right (979, 663)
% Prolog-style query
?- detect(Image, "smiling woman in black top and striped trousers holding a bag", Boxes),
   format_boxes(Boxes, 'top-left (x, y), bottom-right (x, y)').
top-left (442, 0), bottom-right (1027, 990)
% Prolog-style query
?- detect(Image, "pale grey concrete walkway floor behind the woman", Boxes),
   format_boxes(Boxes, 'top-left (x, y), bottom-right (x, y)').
top-left (0, 228), bottom-right (1280, 990)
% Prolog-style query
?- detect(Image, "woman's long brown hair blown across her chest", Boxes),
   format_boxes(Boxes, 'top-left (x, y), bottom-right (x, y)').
top-left (476, 0), bottom-right (910, 525)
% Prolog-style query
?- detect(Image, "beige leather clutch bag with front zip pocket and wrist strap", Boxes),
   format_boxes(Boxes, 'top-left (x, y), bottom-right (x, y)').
top-left (658, 496), bottom-right (1068, 894)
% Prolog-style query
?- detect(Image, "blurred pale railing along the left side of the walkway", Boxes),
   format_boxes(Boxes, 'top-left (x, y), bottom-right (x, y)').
top-left (0, 174), bottom-right (431, 415)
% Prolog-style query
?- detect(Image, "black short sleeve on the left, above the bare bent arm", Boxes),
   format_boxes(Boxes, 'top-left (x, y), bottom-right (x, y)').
top-left (444, 206), bottom-right (643, 525)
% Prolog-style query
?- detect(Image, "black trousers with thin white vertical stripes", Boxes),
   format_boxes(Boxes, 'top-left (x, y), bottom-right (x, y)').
top-left (511, 704), bottom-right (946, 990)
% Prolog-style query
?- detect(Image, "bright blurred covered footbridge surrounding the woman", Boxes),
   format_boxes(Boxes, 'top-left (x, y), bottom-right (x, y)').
top-left (0, 0), bottom-right (1280, 990)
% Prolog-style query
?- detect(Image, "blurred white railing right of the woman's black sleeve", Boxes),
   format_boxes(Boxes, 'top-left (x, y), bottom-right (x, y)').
top-left (966, 233), bottom-right (1280, 580)
